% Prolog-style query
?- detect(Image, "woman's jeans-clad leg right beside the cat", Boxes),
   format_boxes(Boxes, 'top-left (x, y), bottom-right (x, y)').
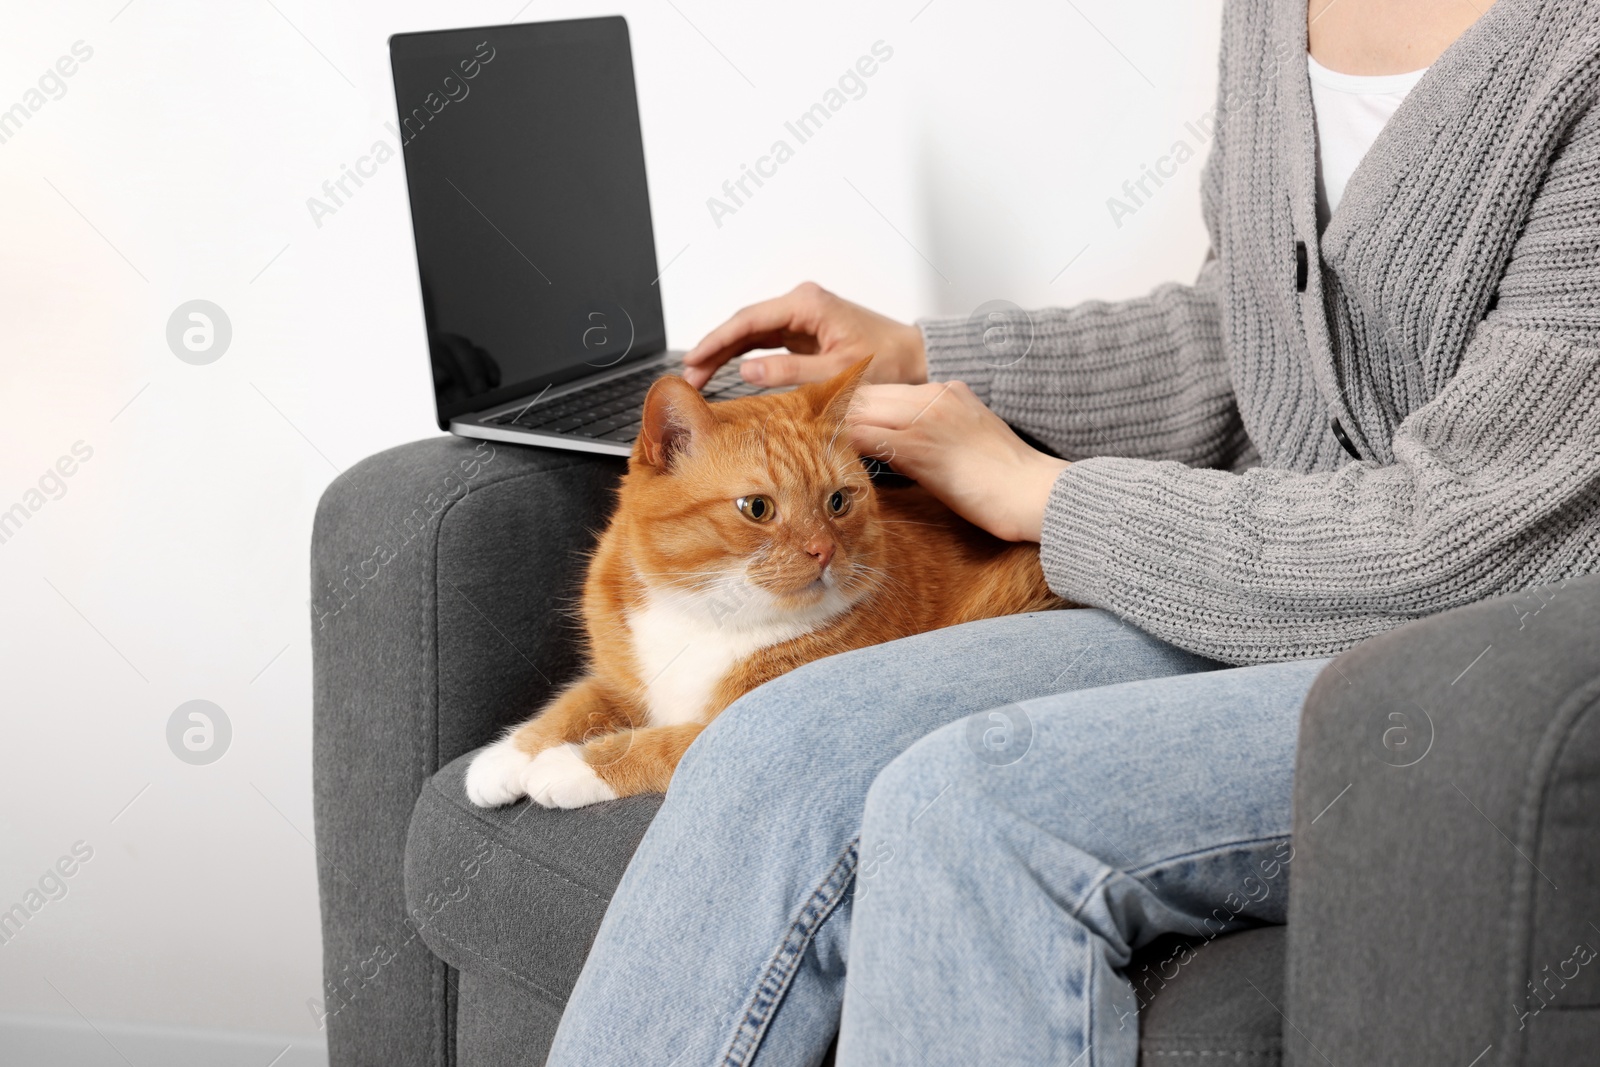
top-left (549, 609), bottom-right (1221, 1067)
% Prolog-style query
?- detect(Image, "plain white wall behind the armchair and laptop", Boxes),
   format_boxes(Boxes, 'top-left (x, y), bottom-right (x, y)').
top-left (0, 0), bottom-right (1221, 1062)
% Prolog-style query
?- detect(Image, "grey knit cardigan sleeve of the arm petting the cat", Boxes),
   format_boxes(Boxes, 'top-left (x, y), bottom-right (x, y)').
top-left (1042, 325), bottom-right (1600, 664)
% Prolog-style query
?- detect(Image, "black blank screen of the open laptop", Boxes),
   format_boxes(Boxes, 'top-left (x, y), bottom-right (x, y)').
top-left (389, 16), bottom-right (666, 429)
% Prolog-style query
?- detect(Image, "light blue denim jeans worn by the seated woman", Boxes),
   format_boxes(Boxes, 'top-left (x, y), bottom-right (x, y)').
top-left (547, 609), bottom-right (1325, 1067)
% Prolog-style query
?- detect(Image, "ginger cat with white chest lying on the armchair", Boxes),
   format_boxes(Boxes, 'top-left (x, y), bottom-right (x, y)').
top-left (467, 360), bottom-right (1064, 808)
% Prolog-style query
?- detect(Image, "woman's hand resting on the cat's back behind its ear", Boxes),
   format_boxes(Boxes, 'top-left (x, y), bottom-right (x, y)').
top-left (851, 382), bottom-right (1072, 541)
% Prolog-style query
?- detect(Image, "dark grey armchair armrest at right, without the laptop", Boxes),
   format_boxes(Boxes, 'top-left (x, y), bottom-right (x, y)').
top-left (1285, 576), bottom-right (1600, 1067)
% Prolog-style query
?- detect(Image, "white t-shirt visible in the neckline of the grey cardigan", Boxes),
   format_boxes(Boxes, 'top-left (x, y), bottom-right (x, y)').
top-left (1306, 56), bottom-right (1427, 226)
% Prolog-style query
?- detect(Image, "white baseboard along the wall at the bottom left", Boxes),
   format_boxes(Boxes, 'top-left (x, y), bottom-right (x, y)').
top-left (0, 1014), bottom-right (328, 1067)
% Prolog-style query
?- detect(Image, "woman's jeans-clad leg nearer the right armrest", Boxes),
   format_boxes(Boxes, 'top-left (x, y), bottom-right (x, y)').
top-left (838, 659), bottom-right (1326, 1067)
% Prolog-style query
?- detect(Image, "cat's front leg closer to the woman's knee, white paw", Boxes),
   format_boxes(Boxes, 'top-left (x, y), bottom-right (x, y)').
top-left (525, 723), bottom-right (706, 808)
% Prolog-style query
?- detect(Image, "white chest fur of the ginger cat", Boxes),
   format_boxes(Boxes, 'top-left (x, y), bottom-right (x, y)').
top-left (627, 582), bottom-right (850, 726)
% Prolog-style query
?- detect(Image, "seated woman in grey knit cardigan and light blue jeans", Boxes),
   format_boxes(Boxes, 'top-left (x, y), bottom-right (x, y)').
top-left (549, 0), bottom-right (1600, 1067)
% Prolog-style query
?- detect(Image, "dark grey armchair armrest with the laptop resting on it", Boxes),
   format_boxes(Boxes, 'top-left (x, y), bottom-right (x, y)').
top-left (310, 437), bottom-right (624, 1067)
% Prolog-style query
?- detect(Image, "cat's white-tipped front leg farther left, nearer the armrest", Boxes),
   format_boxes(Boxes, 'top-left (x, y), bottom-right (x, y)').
top-left (466, 677), bottom-right (634, 808)
